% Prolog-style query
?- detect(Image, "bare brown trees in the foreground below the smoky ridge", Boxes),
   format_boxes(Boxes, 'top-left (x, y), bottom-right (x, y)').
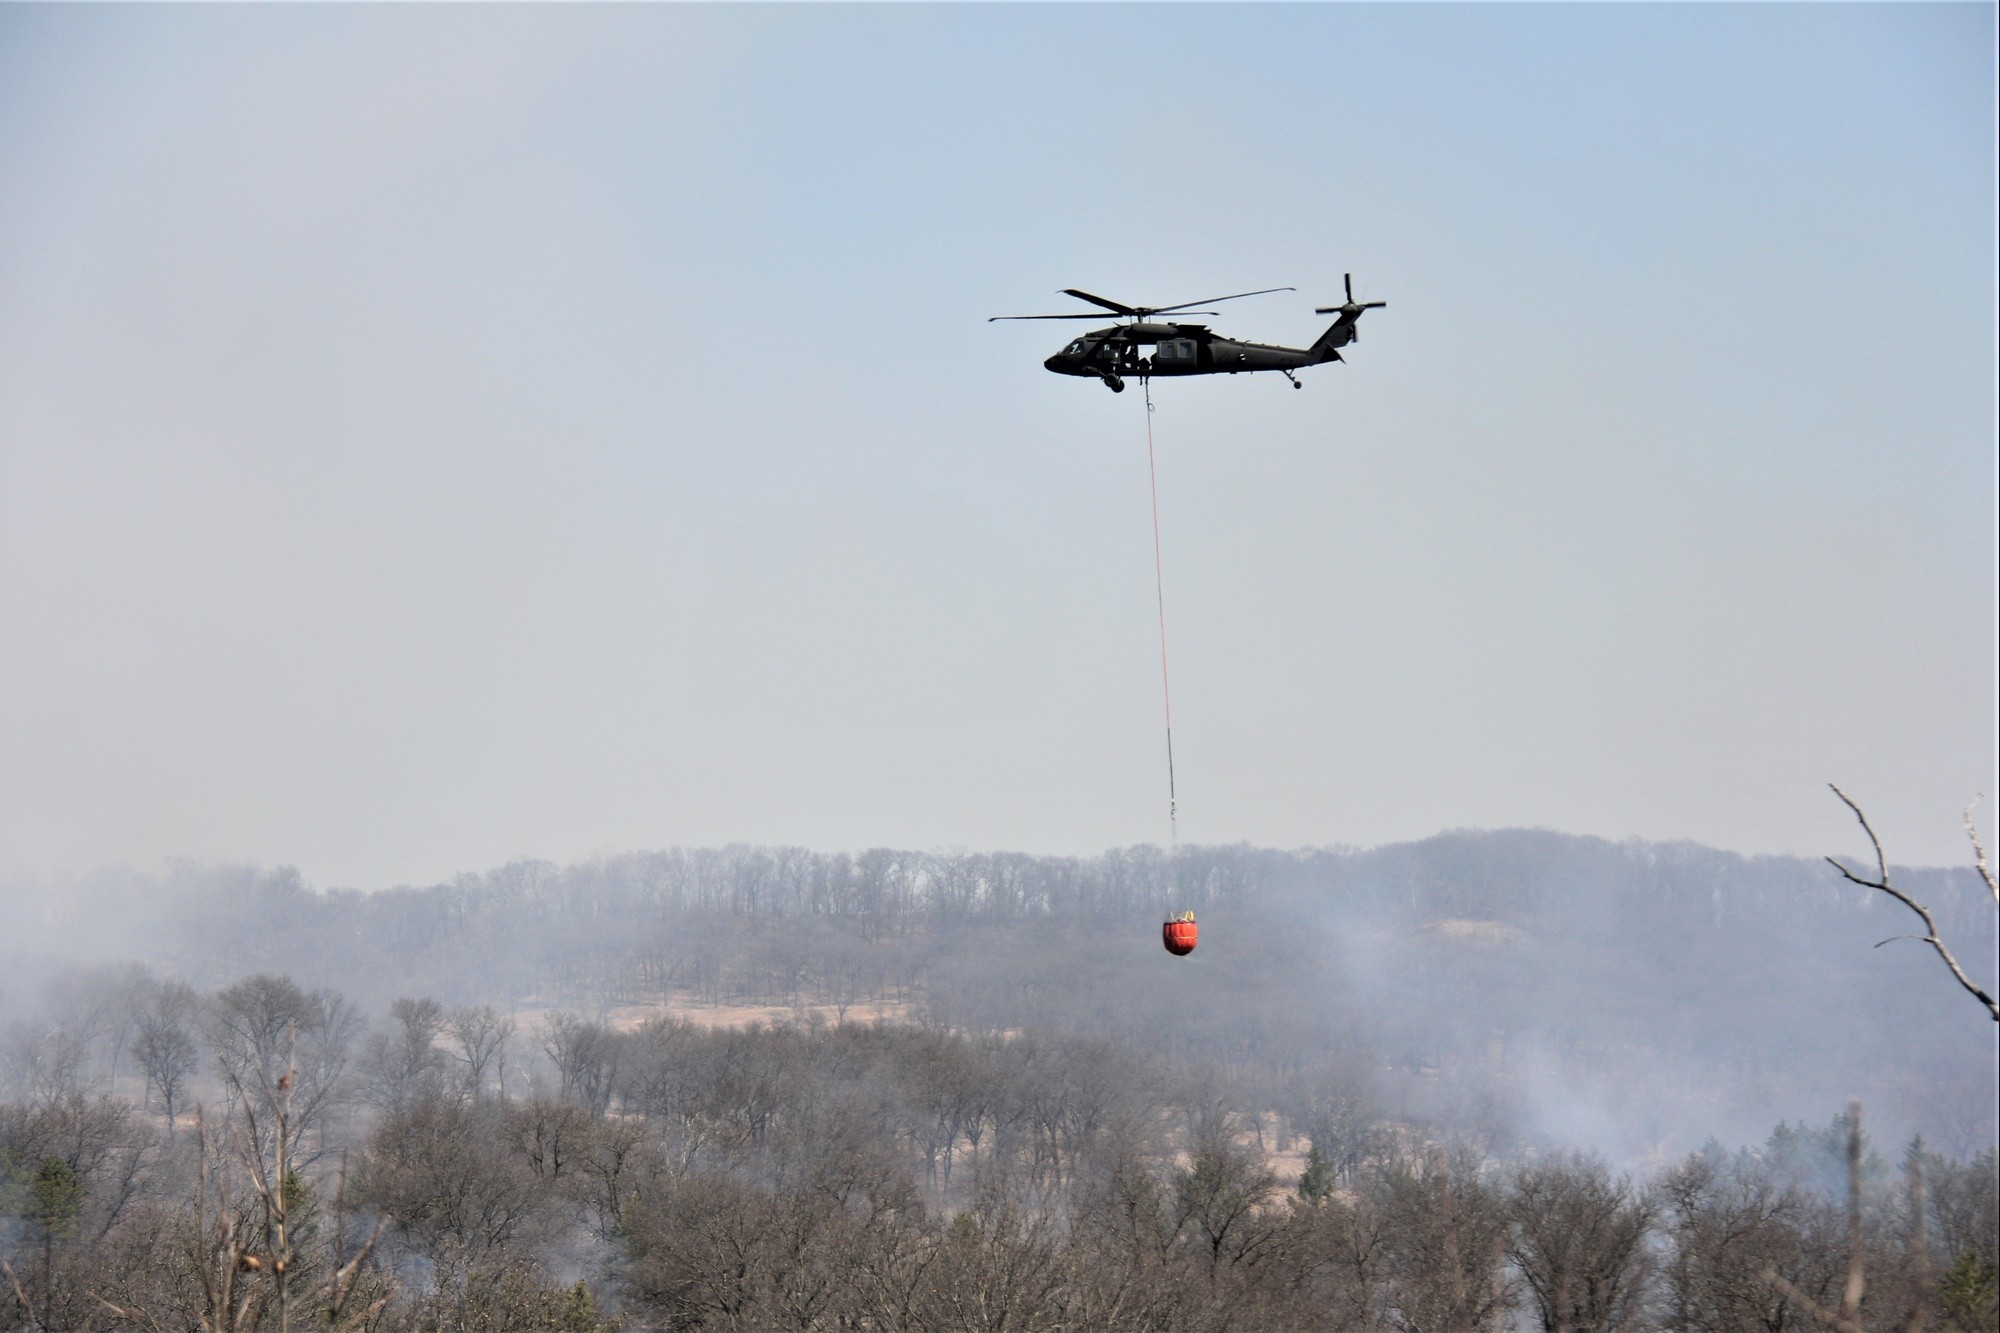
top-left (0, 969), bottom-right (2000, 1333)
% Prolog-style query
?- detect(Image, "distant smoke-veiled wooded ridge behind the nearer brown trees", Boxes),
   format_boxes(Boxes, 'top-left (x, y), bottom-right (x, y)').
top-left (0, 831), bottom-right (1996, 1157)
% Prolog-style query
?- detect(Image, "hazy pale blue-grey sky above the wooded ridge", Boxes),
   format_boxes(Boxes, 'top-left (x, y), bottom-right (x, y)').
top-left (0, 4), bottom-right (1996, 887)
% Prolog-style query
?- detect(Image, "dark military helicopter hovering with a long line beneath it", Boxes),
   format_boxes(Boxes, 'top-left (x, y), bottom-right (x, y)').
top-left (986, 274), bottom-right (1388, 394)
